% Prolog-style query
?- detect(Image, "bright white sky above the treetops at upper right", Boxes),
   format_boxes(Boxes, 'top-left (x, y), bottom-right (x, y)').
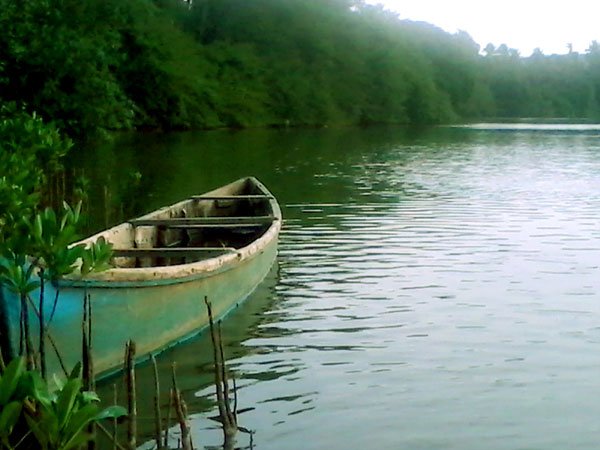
top-left (367, 0), bottom-right (600, 56)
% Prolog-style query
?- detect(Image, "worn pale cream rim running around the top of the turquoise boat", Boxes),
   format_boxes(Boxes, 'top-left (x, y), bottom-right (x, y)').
top-left (58, 177), bottom-right (282, 288)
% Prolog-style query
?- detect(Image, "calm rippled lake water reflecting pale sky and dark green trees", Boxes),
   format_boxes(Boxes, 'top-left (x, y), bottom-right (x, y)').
top-left (79, 124), bottom-right (600, 450)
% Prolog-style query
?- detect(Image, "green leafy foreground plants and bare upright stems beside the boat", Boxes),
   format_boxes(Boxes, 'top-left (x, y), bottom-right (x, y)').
top-left (0, 110), bottom-right (247, 450)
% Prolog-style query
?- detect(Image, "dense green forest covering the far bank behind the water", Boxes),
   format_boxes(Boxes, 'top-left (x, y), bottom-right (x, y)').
top-left (0, 0), bottom-right (600, 137)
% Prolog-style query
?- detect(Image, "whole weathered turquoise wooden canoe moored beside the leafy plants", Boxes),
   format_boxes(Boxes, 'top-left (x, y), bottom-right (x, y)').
top-left (0, 177), bottom-right (281, 377)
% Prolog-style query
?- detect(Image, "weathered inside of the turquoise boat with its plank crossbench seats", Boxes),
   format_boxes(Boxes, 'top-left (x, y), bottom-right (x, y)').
top-left (100, 178), bottom-right (278, 268)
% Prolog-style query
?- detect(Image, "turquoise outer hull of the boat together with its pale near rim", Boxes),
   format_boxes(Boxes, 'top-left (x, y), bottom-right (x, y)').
top-left (0, 177), bottom-right (281, 377)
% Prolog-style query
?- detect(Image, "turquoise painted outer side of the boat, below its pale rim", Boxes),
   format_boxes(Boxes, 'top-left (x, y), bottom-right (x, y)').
top-left (1, 232), bottom-right (277, 376)
